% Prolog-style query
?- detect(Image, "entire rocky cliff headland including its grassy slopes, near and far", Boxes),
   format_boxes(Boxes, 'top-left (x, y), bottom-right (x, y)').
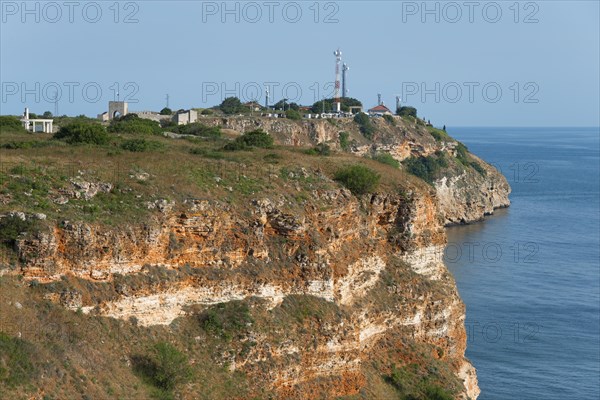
top-left (0, 118), bottom-right (509, 399)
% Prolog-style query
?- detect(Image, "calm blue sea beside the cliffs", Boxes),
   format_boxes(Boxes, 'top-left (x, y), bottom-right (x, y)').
top-left (445, 128), bottom-right (600, 400)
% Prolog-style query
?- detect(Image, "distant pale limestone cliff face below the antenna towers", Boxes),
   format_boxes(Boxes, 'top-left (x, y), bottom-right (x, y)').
top-left (202, 117), bottom-right (510, 225)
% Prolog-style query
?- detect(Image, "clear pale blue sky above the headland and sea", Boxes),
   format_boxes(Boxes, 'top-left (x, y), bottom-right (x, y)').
top-left (0, 0), bottom-right (600, 126)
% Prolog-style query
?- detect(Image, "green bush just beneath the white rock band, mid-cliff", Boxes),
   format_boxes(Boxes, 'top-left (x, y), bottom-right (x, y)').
top-left (199, 301), bottom-right (254, 341)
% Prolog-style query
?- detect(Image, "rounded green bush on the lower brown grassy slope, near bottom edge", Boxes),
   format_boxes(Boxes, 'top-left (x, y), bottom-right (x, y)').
top-left (132, 342), bottom-right (192, 392)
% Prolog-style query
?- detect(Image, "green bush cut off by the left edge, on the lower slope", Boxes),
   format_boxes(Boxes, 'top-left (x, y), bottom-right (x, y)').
top-left (0, 332), bottom-right (37, 387)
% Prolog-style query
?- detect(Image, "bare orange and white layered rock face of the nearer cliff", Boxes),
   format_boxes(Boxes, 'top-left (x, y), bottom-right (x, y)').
top-left (17, 188), bottom-right (478, 399)
